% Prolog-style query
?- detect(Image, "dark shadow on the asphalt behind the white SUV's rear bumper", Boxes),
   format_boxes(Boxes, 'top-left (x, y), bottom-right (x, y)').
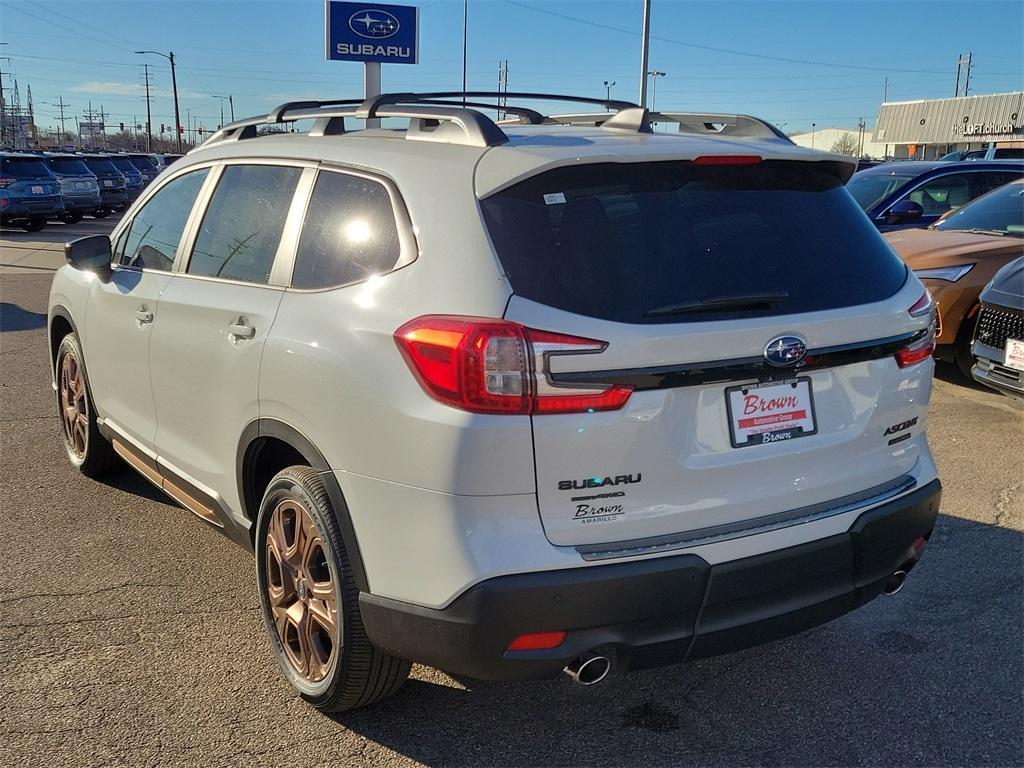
top-left (330, 512), bottom-right (1024, 766)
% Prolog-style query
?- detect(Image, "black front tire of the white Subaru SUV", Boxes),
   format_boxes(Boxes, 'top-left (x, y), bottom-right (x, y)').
top-left (55, 333), bottom-right (121, 477)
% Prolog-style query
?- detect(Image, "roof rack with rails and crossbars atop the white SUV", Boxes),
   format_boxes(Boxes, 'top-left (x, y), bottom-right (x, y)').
top-left (204, 91), bottom-right (790, 146)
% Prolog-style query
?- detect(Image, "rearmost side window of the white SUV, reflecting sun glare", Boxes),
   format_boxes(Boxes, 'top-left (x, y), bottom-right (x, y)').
top-left (292, 171), bottom-right (401, 288)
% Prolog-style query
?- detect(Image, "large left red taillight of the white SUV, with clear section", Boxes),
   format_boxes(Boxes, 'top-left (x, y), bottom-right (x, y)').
top-left (394, 315), bottom-right (633, 415)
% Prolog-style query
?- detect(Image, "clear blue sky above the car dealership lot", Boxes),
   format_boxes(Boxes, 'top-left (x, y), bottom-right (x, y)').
top-left (0, 0), bottom-right (1024, 137)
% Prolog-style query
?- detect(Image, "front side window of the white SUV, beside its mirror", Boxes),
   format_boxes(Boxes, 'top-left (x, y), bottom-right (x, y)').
top-left (118, 168), bottom-right (209, 271)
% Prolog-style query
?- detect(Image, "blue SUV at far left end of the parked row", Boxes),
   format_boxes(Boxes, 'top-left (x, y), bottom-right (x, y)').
top-left (0, 153), bottom-right (63, 232)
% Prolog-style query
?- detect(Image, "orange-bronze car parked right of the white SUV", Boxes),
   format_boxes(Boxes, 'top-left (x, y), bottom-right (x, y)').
top-left (883, 179), bottom-right (1024, 377)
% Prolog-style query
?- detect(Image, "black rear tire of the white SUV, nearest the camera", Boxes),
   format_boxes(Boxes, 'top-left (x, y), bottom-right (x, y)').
top-left (256, 467), bottom-right (411, 712)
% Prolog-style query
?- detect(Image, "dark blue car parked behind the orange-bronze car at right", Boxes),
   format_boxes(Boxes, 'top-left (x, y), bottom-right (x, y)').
top-left (846, 160), bottom-right (1024, 232)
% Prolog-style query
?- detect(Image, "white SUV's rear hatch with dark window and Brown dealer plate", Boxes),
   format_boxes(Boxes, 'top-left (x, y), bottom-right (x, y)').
top-left (481, 157), bottom-right (933, 557)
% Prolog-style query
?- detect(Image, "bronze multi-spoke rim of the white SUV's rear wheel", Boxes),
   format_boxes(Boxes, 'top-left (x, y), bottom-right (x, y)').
top-left (266, 499), bottom-right (341, 683)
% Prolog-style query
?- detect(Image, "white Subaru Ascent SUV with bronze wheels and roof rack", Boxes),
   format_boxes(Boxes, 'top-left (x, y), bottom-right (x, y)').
top-left (49, 93), bottom-right (941, 710)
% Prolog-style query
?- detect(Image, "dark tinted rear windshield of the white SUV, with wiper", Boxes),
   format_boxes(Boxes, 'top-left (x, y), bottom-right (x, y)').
top-left (481, 161), bottom-right (906, 323)
